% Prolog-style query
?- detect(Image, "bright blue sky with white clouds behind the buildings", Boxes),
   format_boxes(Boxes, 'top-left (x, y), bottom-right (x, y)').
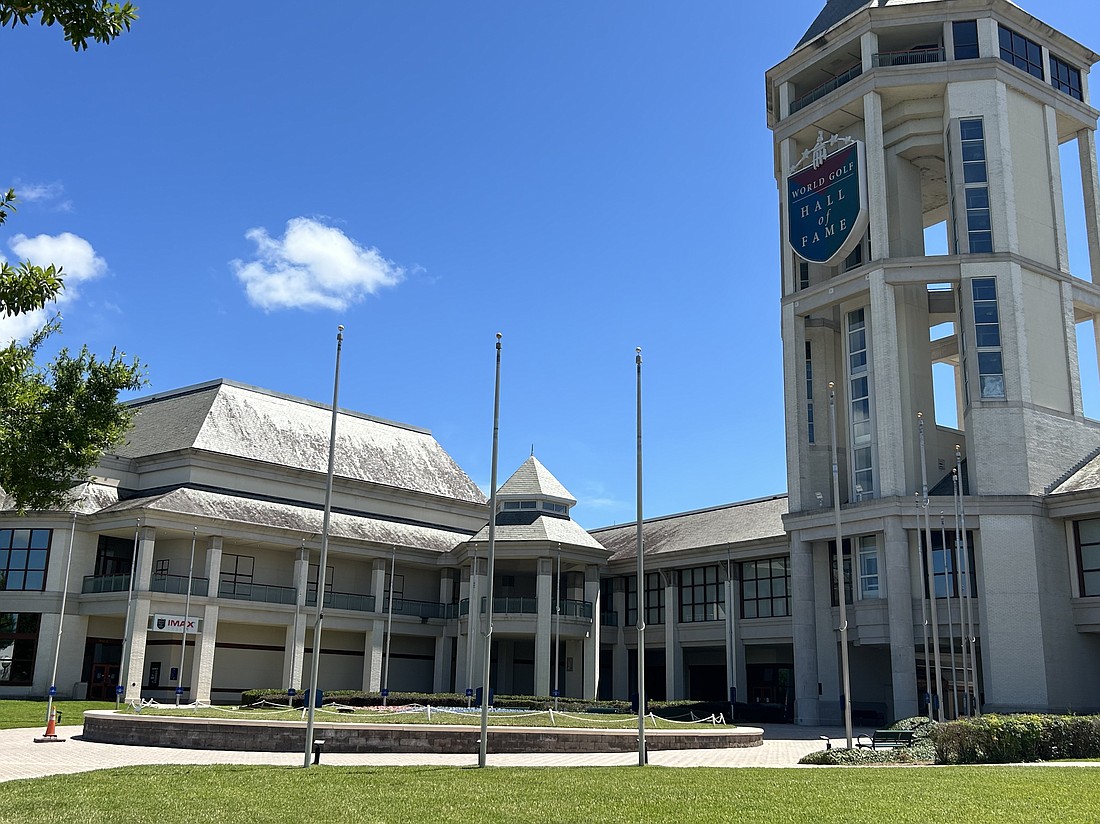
top-left (0, 0), bottom-right (1100, 528)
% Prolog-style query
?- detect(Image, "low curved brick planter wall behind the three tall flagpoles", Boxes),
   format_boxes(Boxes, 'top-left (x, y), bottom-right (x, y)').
top-left (84, 710), bottom-right (763, 754)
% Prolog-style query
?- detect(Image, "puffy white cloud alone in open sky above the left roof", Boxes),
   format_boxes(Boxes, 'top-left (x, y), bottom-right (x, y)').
top-left (231, 218), bottom-right (405, 311)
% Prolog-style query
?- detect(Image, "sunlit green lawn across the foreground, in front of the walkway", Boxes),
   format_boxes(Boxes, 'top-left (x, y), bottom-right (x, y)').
top-left (0, 766), bottom-right (1100, 824)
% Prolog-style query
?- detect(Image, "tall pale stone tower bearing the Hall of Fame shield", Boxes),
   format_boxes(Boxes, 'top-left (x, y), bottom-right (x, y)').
top-left (767, 0), bottom-right (1100, 723)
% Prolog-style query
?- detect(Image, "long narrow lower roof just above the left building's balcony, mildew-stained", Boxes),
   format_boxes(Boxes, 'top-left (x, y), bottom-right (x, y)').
top-left (100, 488), bottom-right (470, 552)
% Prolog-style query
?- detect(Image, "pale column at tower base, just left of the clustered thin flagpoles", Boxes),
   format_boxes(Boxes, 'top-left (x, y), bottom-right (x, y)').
top-left (879, 518), bottom-right (919, 718)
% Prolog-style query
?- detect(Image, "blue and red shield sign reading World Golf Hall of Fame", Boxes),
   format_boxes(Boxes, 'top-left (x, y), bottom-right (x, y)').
top-left (787, 132), bottom-right (869, 265)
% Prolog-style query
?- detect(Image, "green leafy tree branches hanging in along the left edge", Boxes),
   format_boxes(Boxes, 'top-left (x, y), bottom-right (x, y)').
top-left (0, 0), bottom-right (145, 513)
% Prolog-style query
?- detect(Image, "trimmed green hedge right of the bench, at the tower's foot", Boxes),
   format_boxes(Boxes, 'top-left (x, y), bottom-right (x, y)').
top-left (933, 714), bottom-right (1100, 763)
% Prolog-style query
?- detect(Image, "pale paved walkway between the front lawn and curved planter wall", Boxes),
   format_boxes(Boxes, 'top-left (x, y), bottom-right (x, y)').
top-left (0, 725), bottom-right (869, 781)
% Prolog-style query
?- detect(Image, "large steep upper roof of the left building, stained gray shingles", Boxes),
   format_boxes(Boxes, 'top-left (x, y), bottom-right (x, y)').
top-left (116, 381), bottom-right (485, 504)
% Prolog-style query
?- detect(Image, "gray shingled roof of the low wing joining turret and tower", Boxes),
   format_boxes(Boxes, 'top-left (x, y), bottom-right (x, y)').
top-left (592, 495), bottom-right (787, 561)
